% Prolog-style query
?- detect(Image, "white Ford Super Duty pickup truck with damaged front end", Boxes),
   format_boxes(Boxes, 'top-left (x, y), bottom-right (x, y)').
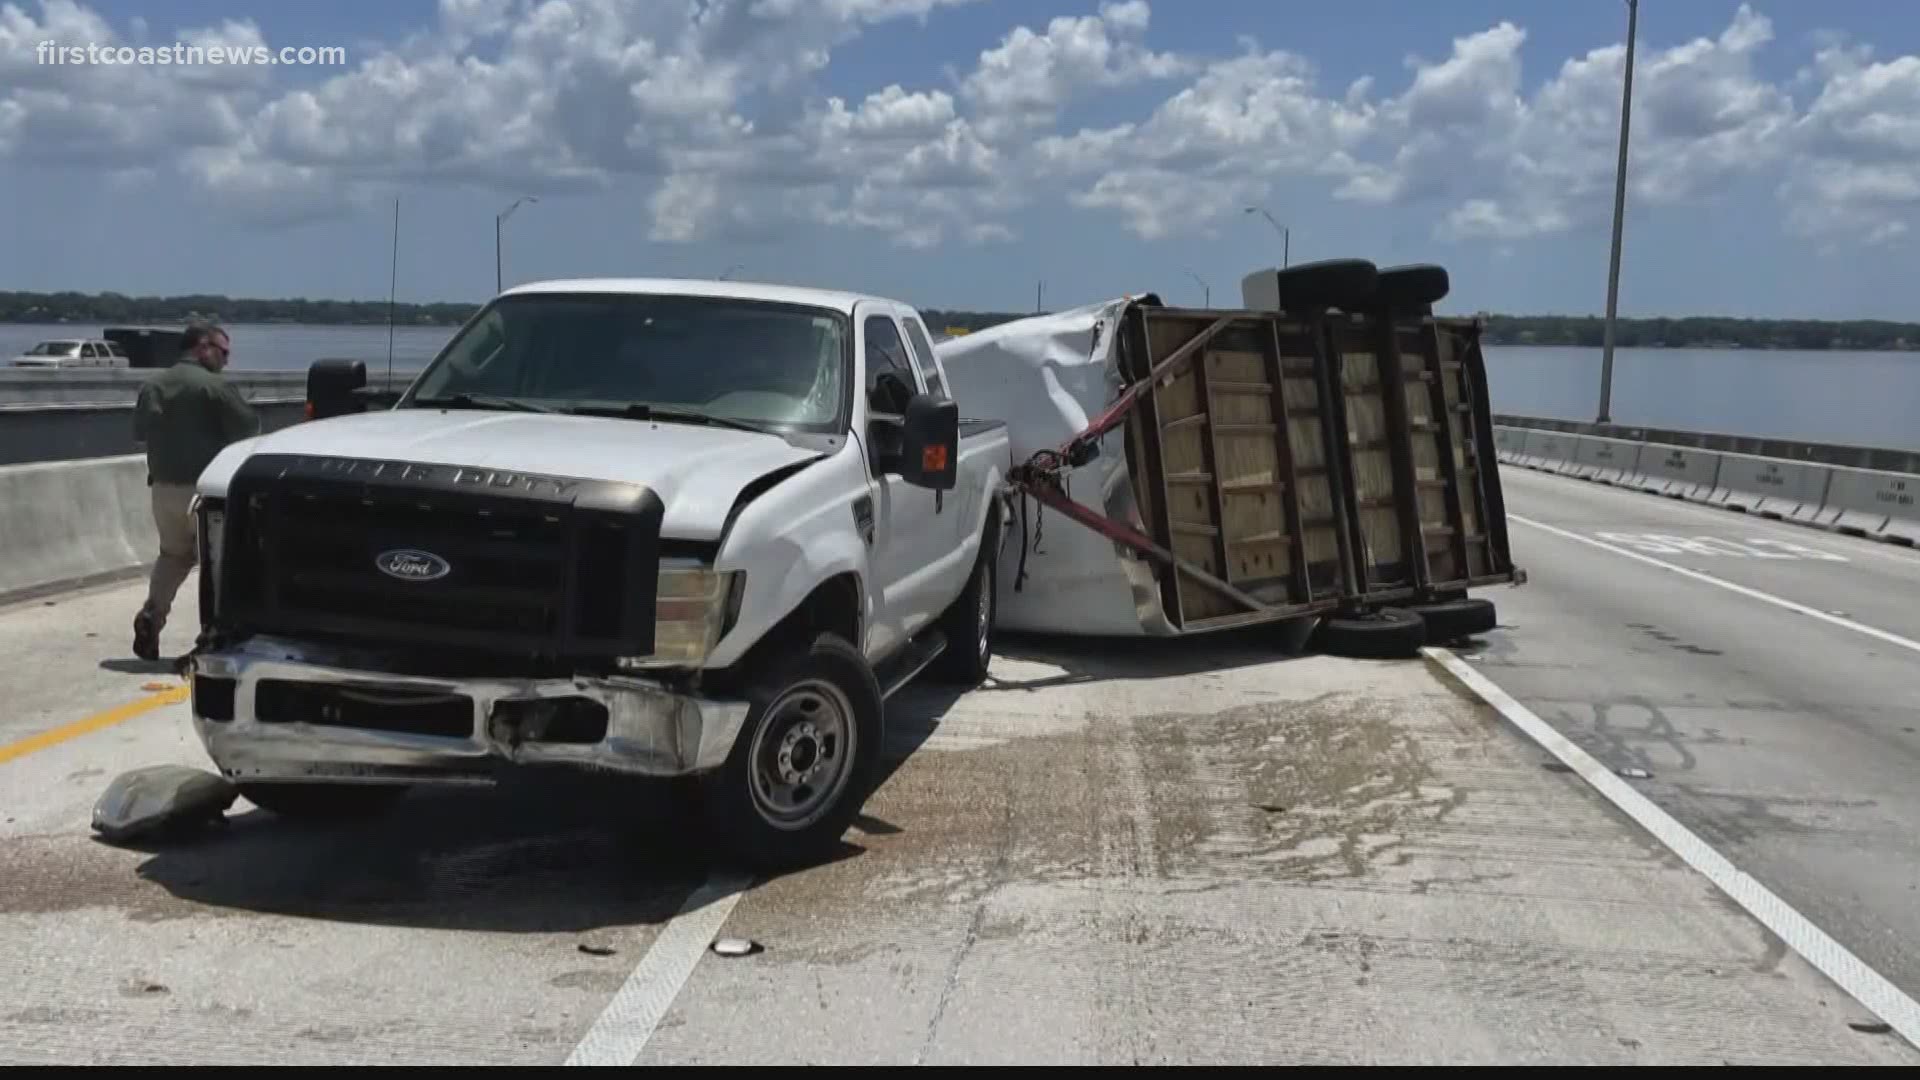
top-left (188, 281), bottom-right (1010, 867)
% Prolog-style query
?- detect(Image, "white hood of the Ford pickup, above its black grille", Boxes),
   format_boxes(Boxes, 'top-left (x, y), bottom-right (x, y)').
top-left (200, 409), bottom-right (822, 540)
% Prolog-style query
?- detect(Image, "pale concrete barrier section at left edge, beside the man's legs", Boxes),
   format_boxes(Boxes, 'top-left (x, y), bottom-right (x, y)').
top-left (0, 455), bottom-right (159, 617)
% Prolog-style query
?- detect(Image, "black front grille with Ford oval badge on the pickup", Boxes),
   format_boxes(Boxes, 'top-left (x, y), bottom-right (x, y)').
top-left (213, 454), bottom-right (664, 659)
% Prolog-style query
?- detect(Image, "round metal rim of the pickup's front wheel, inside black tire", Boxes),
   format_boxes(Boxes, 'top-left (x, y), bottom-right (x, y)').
top-left (751, 678), bottom-right (858, 830)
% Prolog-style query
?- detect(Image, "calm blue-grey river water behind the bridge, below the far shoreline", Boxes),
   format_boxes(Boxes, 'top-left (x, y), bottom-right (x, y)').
top-left (0, 323), bottom-right (1920, 450)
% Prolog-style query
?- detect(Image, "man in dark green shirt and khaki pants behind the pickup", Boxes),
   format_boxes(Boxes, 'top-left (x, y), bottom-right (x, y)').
top-left (132, 323), bottom-right (259, 659)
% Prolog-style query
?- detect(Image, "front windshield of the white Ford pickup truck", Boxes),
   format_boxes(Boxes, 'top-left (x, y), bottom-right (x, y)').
top-left (399, 294), bottom-right (852, 430)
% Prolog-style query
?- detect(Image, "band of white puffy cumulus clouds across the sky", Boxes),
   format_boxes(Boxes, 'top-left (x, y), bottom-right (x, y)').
top-left (0, 0), bottom-right (1920, 248)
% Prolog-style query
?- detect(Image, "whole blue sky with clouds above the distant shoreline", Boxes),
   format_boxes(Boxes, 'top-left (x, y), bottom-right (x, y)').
top-left (0, 0), bottom-right (1920, 319)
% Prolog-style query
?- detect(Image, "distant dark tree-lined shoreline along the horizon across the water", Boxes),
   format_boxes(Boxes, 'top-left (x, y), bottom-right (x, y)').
top-left (0, 292), bottom-right (1920, 352)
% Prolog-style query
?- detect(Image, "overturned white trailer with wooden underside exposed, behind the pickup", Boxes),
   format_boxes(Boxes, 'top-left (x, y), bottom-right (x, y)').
top-left (937, 259), bottom-right (1524, 655)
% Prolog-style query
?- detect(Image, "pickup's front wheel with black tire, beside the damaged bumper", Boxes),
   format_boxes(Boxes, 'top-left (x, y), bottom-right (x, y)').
top-left (701, 632), bottom-right (883, 872)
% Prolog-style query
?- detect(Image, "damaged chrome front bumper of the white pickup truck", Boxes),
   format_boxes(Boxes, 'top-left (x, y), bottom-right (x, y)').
top-left (190, 638), bottom-right (749, 782)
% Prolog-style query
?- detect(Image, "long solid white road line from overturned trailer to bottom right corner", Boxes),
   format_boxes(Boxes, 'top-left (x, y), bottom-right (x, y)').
top-left (1421, 646), bottom-right (1920, 1045)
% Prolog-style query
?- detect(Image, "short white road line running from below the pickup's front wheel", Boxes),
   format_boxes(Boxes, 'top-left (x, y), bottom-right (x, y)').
top-left (566, 876), bottom-right (749, 1065)
